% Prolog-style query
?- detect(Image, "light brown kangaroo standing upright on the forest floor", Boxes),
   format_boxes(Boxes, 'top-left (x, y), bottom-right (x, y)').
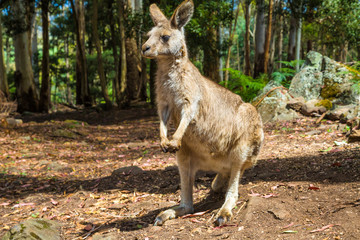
top-left (142, 0), bottom-right (264, 226)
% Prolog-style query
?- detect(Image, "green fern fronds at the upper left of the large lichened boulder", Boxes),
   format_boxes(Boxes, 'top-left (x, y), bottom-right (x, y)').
top-left (271, 60), bottom-right (305, 88)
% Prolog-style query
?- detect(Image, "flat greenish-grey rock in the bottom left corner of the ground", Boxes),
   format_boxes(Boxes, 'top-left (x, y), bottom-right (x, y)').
top-left (2, 219), bottom-right (62, 240)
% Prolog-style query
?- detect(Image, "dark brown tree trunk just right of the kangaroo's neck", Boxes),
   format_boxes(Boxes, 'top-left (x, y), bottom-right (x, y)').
top-left (203, 28), bottom-right (221, 83)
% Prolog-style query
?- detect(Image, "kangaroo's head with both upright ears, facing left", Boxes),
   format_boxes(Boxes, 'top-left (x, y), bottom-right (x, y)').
top-left (142, 0), bottom-right (194, 58)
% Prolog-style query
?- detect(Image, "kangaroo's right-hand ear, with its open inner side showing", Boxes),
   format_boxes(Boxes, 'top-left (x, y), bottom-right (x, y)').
top-left (170, 0), bottom-right (194, 29)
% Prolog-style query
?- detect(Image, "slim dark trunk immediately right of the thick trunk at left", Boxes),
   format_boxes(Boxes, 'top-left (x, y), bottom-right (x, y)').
top-left (39, 0), bottom-right (51, 113)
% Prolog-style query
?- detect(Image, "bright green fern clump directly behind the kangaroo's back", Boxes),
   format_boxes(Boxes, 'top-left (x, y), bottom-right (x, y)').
top-left (220, 68), bottom-right (268, 102)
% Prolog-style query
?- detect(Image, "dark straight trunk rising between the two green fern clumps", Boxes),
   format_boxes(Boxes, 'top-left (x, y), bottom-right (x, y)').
top-left (254, 0), bottom-right (266, 78)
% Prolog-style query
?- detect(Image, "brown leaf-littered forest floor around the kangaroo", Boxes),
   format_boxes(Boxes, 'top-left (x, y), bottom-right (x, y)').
top-left (0, 105), bottom-right (360, 240)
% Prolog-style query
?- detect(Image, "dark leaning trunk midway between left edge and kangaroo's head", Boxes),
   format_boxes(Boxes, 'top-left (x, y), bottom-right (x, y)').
top-left (70, 0), bottom-right (92, 107)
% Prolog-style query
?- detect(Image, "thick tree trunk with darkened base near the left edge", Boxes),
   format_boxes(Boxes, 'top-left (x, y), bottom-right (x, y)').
top-left (12, 0), bottom-right (39, 113)
